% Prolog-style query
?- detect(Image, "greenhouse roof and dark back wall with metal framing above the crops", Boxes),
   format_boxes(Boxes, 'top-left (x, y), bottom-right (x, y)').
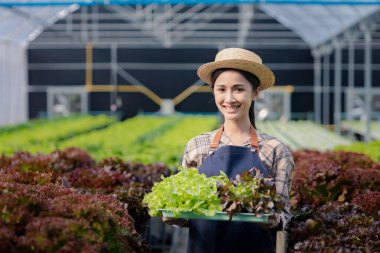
top-left (0, 1), bottom-right (379, 134)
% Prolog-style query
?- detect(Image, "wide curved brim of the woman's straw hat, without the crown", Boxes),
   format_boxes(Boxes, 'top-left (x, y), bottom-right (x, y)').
top-left (197, 59), bottom-right (275, 90)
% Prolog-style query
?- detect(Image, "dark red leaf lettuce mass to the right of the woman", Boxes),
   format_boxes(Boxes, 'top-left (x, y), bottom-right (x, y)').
top-left (289, 151), bottom-right (380, 253)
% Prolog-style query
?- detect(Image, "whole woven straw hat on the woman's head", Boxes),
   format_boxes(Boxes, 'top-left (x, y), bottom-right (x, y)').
top-left (197, 48), bottom-right (275, 90)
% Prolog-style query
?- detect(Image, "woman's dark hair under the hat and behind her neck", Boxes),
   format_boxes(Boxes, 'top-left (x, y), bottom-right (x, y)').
top-left (211, 68), bottom-right (260, 129)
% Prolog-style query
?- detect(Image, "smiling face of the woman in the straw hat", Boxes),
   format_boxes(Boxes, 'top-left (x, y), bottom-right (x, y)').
top-left (214, 70), bottom-right (257, 120)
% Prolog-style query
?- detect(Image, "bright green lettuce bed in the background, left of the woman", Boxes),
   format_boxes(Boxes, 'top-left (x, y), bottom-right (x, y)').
top-left (0, 116), bottom-right (218, 165)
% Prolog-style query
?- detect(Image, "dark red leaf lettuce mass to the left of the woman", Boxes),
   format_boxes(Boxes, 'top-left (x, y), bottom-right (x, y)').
top-left (0, 148), bottom-right (169, 253)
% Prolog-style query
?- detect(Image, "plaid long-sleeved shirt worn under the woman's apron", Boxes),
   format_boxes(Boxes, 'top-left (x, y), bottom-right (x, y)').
top-left (182, 130), bottom-right (294, 226)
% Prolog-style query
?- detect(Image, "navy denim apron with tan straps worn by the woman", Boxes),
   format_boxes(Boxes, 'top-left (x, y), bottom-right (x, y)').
top-left (187, 126), bottom-right (274, 253)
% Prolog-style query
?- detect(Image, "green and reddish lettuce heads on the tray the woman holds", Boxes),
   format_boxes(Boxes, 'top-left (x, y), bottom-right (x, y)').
top-left (143, 168), bottom-right (283, 218)
